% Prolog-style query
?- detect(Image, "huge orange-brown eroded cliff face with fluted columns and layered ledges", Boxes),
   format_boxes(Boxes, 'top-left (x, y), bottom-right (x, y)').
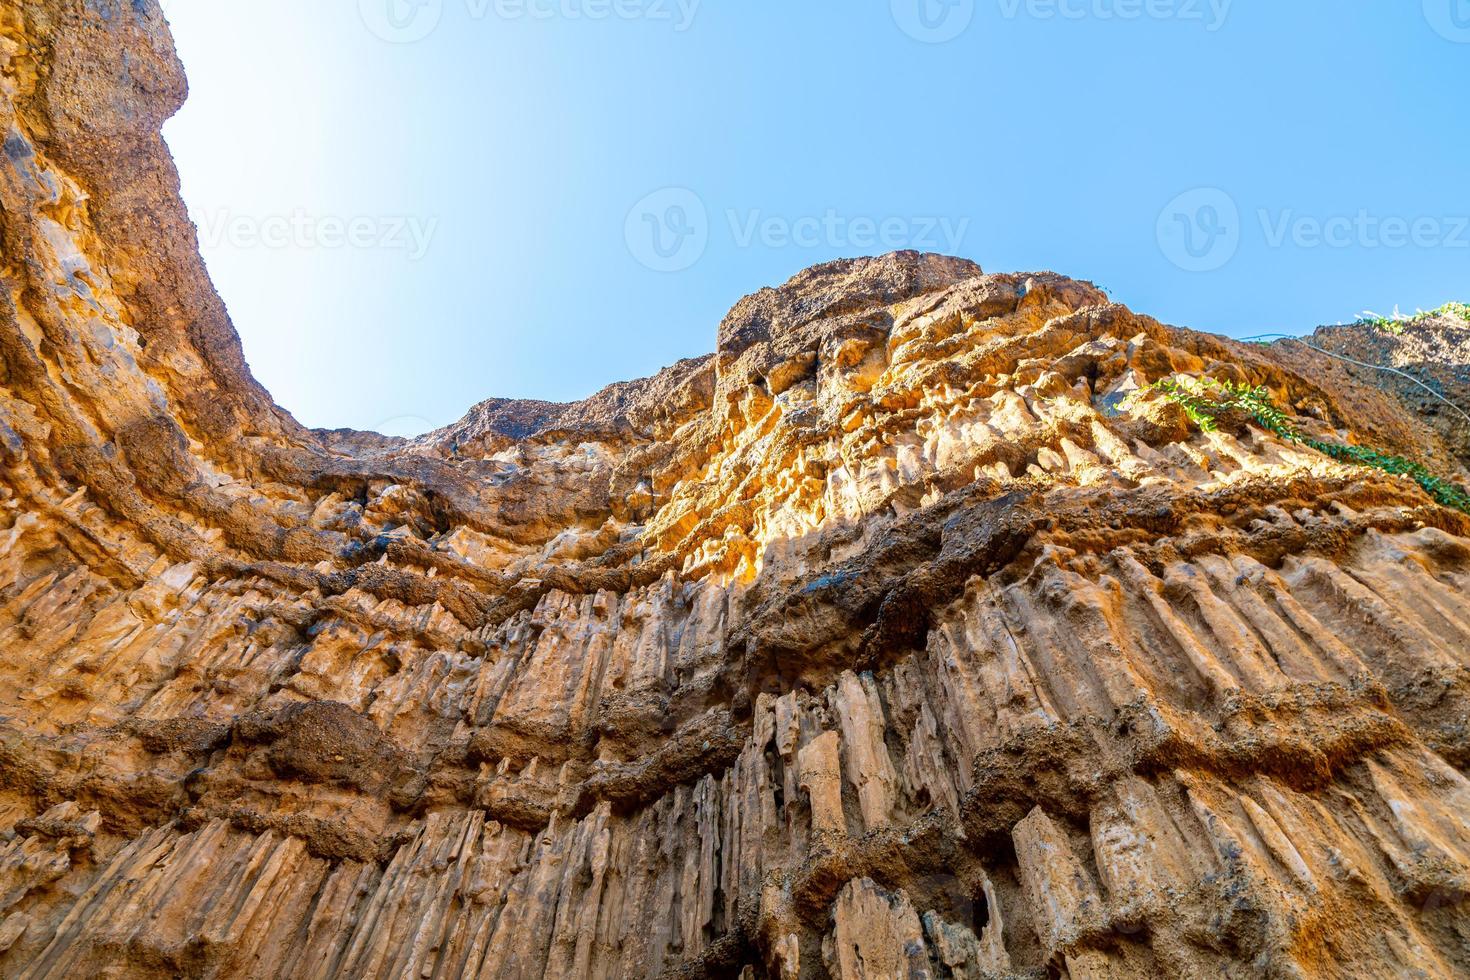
top-left (0, 0), bottom-right (1470, 980)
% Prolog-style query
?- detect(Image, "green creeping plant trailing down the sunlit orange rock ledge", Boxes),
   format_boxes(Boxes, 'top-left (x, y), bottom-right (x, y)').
top-left (1142, 378), bottom-right (1470, 514)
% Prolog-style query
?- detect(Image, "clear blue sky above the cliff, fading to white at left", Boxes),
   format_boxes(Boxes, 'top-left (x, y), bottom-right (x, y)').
top-left (165, 0), bottom-right (1470, 435)
